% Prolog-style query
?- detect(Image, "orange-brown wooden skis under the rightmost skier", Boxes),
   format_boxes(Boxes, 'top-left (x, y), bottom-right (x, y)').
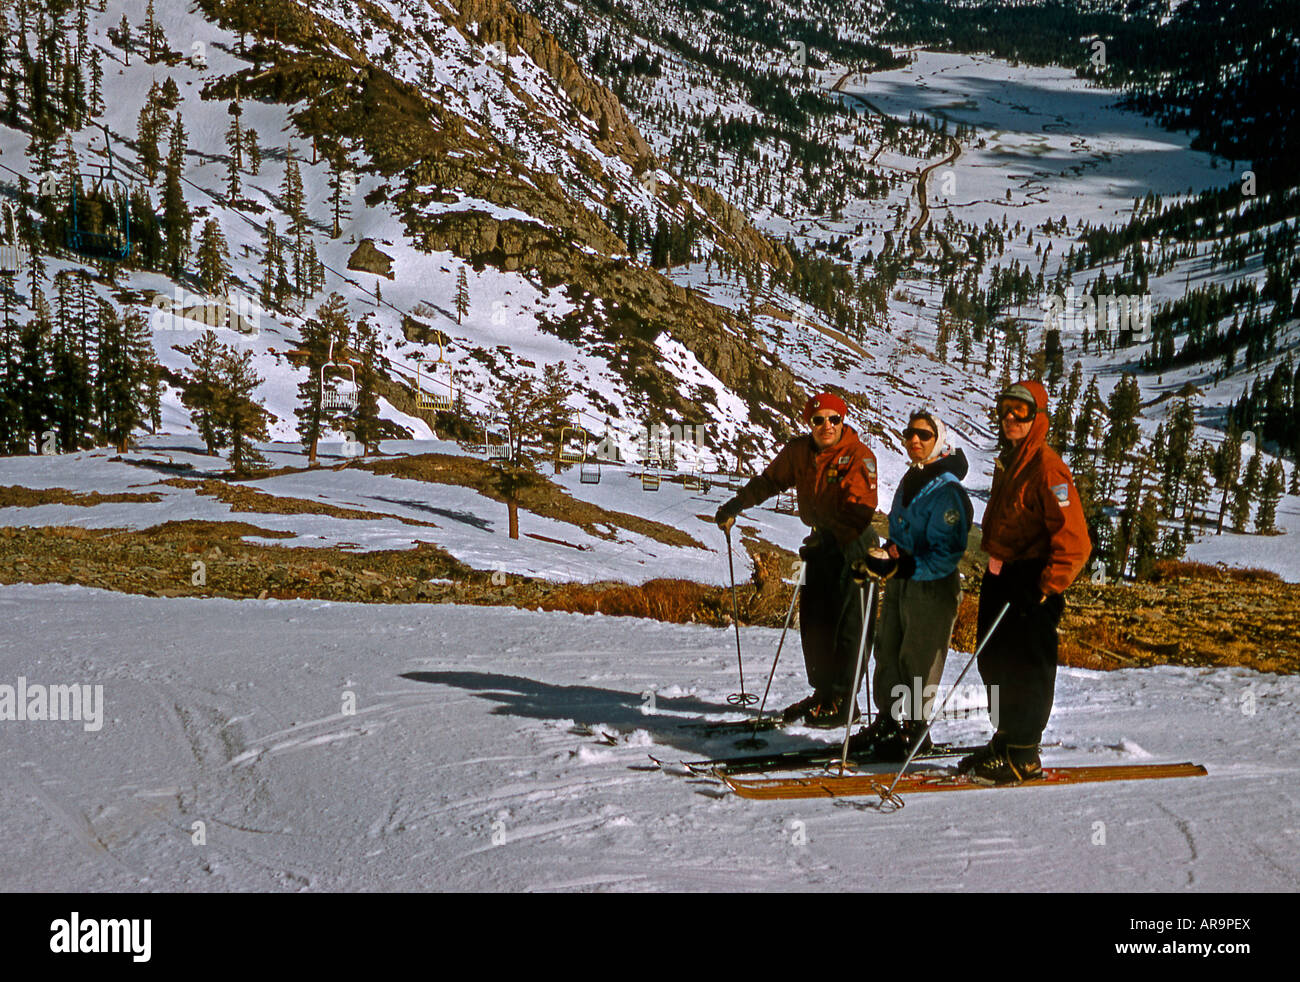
top-left (719, 763), bottom-right (1206, 799)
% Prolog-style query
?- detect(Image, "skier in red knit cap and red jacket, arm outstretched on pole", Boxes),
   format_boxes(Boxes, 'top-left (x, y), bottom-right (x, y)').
top-left (715, 393), bottom-right (878, 727)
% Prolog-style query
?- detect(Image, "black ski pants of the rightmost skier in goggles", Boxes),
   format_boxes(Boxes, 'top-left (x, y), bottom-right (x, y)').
top-left (979, 562), bottom-right (1065, 747)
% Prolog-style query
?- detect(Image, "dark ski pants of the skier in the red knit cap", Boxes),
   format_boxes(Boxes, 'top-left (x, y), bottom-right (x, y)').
top-left (800, 533), bottom-right (866, 693)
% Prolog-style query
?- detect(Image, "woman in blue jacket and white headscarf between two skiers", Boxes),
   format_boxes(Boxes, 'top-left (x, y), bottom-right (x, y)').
top-left (849, 410), bottom-right (974, 761)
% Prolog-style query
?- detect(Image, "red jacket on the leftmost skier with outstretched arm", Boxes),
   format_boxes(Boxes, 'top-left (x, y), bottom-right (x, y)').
top-left (736, 425), bottom-right (876, 549)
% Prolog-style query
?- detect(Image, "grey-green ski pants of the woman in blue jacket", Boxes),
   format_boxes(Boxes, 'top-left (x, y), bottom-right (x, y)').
top-left (872, 570), bottom-right (962, 721)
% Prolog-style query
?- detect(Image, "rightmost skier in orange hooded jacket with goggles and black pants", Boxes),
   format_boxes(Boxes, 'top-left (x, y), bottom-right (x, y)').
top-left (958, 381), bottom-right (1092, 784)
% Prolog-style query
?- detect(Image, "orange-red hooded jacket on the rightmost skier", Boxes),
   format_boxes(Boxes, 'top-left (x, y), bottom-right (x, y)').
top-left (980, 382), bottom-right (1092, 593)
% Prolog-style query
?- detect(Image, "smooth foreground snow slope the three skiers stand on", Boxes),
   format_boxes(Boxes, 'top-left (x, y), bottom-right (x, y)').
top-left (0, 585), bottom-right (1300, 892)
